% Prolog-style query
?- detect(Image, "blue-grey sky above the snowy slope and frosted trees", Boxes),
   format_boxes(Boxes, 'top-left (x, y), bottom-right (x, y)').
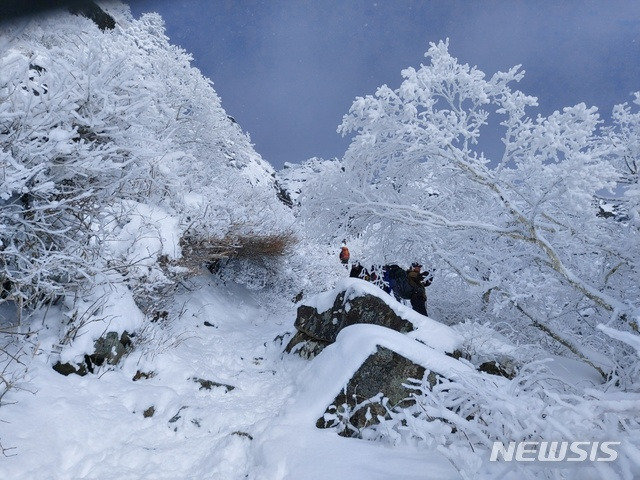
top-left (126, 0), bottom-right (640, 168)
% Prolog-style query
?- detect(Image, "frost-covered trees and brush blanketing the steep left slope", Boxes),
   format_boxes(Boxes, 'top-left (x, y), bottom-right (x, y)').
top-left (0, 3), bottom-right (293, 322)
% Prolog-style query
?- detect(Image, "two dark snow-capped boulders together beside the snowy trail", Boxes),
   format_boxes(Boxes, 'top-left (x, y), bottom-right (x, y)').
top-left (285, 279), bottom-right (470, 437)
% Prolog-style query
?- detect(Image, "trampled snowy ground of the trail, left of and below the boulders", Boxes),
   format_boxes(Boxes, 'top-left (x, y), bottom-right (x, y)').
top-left (0, 277), bottom-right (459, 480)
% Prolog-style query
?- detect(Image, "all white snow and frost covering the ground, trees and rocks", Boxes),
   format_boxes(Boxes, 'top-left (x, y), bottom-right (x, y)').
top-left (0, 4), bottom-right (640, 480)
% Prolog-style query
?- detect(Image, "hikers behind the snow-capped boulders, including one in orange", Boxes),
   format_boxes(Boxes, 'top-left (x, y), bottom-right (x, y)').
top-left (339, 245), bottom-right (433, 316)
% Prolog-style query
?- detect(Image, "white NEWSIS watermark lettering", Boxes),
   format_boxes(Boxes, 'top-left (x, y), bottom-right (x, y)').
top-left (489, 441), bottom-right (621, 462)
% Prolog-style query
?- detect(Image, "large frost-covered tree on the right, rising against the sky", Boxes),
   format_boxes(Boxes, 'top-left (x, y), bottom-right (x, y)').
top-left (303, 42), bottom-right (640, 373)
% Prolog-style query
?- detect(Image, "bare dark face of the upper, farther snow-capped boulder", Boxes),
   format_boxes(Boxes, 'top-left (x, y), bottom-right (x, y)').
top-left (285, 292), bottom-right (414, 358)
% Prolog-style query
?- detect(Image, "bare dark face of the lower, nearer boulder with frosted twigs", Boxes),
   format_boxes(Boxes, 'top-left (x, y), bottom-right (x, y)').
top-left (316, 347), bottom-right (438, 437)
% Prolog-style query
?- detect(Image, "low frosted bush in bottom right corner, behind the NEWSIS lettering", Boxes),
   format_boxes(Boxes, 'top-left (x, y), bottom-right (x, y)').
top-left (325, 360), bottom-right (640, 479)
